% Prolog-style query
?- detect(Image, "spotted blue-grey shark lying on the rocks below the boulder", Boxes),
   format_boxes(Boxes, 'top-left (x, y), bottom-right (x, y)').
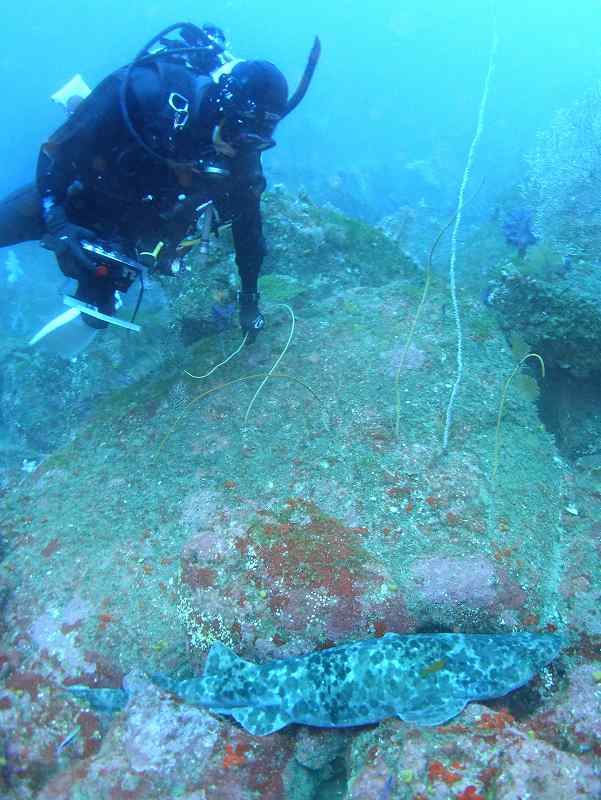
top-left (70, 633), bottom-right (563, 736)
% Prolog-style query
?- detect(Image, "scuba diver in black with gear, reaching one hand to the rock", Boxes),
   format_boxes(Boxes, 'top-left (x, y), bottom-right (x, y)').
top-left (0, 23), bottom-right (320, 350)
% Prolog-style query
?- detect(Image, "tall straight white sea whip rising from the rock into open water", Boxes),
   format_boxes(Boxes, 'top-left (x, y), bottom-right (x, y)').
top-left (442, 18), bottom-right (499, 451)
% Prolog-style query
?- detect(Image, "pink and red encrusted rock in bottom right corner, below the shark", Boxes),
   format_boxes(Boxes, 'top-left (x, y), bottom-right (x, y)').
top-left (345, 705), bottom-right (601, 800)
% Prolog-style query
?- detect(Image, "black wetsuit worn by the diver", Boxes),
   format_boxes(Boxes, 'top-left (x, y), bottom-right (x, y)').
top-left (0, 58), bottom-right (265, 310)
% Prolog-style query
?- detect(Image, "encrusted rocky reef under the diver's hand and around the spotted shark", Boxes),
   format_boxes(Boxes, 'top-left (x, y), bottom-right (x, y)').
top-left (0, 190), bottom-right (601, 800)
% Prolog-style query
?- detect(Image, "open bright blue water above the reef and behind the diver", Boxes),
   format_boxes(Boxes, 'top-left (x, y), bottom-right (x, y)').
top-left (0, 0), bottom-right (601, 210)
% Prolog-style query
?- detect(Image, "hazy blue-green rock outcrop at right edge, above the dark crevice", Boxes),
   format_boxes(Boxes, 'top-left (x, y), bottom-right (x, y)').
top-left (488, 260), bottom-right (601, 462)
